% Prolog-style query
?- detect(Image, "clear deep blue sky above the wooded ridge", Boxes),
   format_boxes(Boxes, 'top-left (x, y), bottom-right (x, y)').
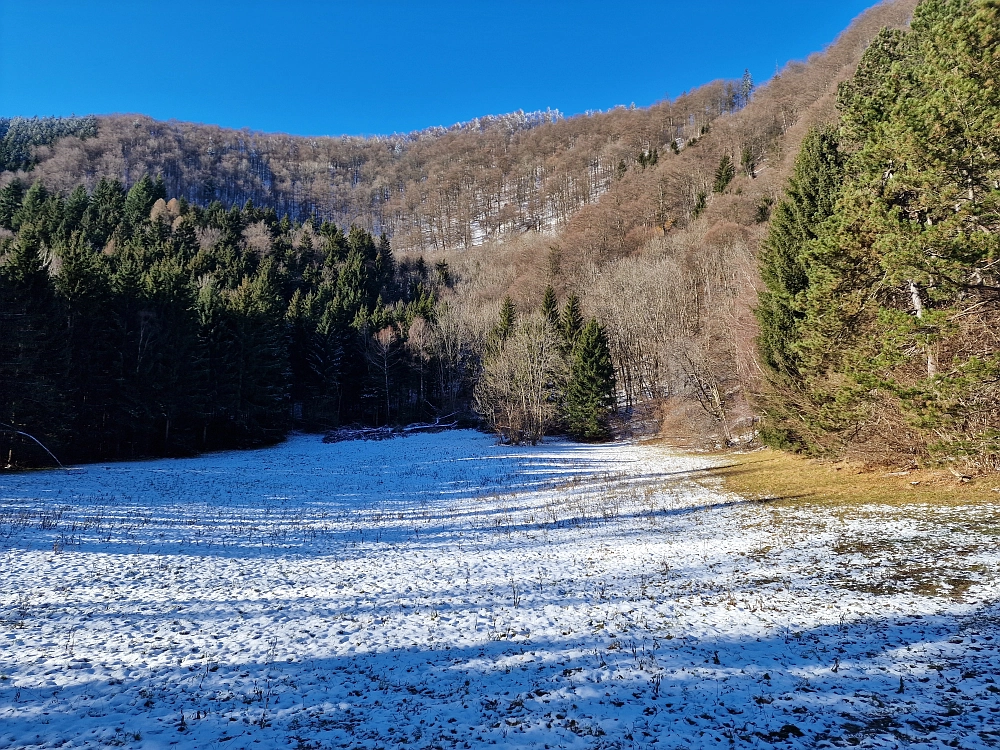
top-left (0, 0), bottom-right (873, 135)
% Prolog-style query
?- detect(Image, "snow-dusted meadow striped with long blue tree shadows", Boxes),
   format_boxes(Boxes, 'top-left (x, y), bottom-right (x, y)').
top-left (0, 432), bottom-right (1000, 748)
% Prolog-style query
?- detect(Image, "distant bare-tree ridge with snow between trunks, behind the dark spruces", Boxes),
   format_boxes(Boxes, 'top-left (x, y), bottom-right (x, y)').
top-left (5, 82), bottom-right (746, 251)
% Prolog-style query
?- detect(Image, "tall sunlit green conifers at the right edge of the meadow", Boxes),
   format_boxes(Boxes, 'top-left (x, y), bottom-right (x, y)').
top-left (757, 0), bottom-right (1000, 469)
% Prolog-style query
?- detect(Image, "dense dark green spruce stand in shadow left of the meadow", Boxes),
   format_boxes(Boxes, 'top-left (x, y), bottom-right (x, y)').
top-left (0, 177), bottom-right (616, 467)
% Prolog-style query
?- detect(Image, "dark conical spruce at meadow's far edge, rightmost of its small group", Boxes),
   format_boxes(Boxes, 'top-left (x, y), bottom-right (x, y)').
top-left (564, 318), bottom-right (616, 441)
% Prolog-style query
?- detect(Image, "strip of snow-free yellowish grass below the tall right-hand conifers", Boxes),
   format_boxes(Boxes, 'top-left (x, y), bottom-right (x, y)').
top-left (711, 449), bottom-right (1000, 505)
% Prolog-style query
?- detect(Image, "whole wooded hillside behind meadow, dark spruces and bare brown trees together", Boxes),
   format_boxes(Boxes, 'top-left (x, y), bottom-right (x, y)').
top-left (0, 0), bottom-right (928, 470)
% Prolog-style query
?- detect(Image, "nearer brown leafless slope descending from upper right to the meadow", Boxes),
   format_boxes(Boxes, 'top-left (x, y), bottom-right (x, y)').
top-left (472, 0), bottom-right (916, 443)
